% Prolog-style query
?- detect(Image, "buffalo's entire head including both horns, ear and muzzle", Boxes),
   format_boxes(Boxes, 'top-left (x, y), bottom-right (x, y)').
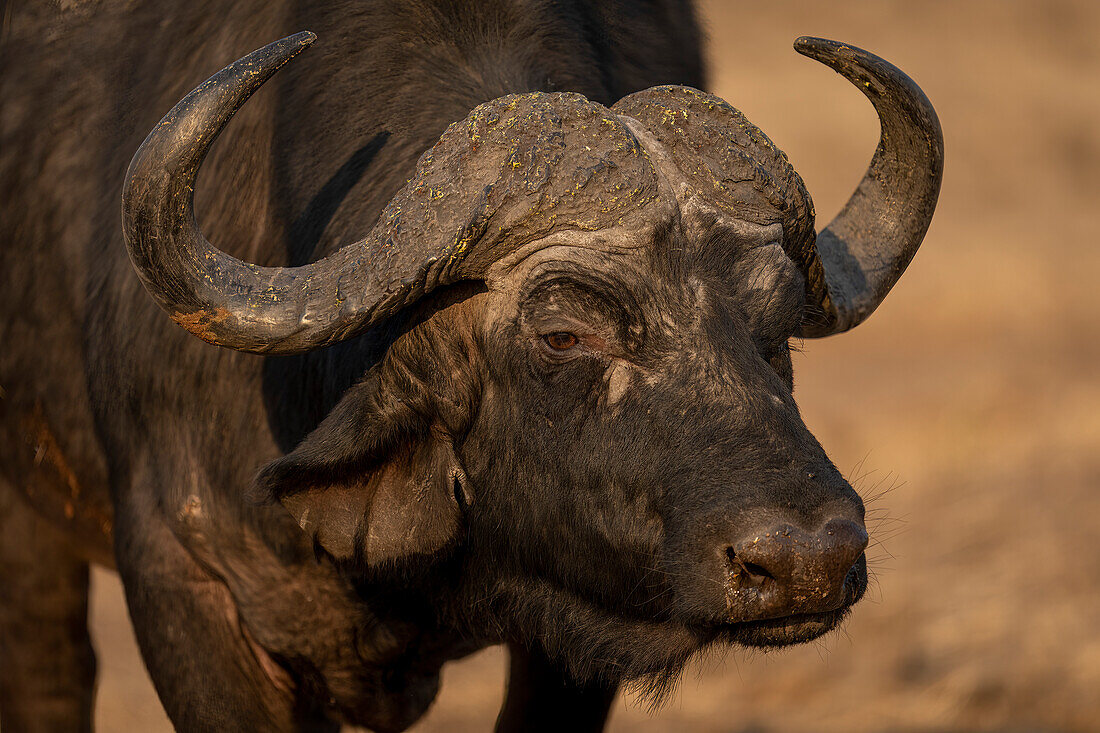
top-left (123, 34), bottom-right (942, 677)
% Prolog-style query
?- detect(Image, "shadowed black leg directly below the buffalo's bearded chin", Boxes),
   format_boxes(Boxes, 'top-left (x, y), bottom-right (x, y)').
top-left (496, 646), bottom-right (617, 733)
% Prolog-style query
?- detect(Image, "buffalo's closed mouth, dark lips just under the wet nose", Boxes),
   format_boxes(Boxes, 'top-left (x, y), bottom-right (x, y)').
top-left (713, 556), bottom-right (867, 647)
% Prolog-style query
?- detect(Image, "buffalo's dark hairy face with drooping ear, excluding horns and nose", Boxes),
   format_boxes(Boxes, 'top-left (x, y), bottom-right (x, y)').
top-left (262, 214), bottom-right (867, 682)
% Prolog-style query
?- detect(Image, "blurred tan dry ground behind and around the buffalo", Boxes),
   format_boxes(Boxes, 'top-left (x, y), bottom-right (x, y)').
top-left (92, 0), bottom-right (1100, 733)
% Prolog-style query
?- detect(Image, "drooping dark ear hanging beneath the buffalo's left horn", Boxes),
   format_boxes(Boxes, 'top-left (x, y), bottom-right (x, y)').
top-left (256, 374), bottom-right (470, 566)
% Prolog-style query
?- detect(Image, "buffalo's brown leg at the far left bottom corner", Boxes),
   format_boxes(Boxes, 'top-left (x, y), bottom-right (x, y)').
top-left (0, 480), bottom-right (96, 732)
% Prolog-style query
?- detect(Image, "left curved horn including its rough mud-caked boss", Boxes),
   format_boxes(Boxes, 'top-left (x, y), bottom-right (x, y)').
top-left (122, 33), bottom-right (659, 354)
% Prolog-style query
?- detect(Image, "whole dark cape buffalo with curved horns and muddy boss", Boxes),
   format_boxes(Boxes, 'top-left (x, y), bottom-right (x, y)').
top-left (0, 0), bottom-right (942, 733)
